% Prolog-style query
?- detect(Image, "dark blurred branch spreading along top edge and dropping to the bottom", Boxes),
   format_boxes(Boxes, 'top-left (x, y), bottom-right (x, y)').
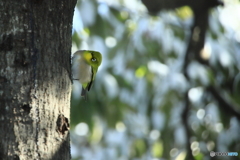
top-left (142, 0), bottom-right (223, 160)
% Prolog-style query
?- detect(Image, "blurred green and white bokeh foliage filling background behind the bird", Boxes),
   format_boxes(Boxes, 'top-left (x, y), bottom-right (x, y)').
top-left (71, 0), bottom-right (240, 160)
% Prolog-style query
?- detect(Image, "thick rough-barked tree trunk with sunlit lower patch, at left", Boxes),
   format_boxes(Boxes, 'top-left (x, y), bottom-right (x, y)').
top-left (0, 0), bottom-right (76, 160)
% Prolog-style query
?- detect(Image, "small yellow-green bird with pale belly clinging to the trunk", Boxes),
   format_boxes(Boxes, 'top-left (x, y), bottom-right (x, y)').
top-left (72, 50), bottom-right (102, 98)
